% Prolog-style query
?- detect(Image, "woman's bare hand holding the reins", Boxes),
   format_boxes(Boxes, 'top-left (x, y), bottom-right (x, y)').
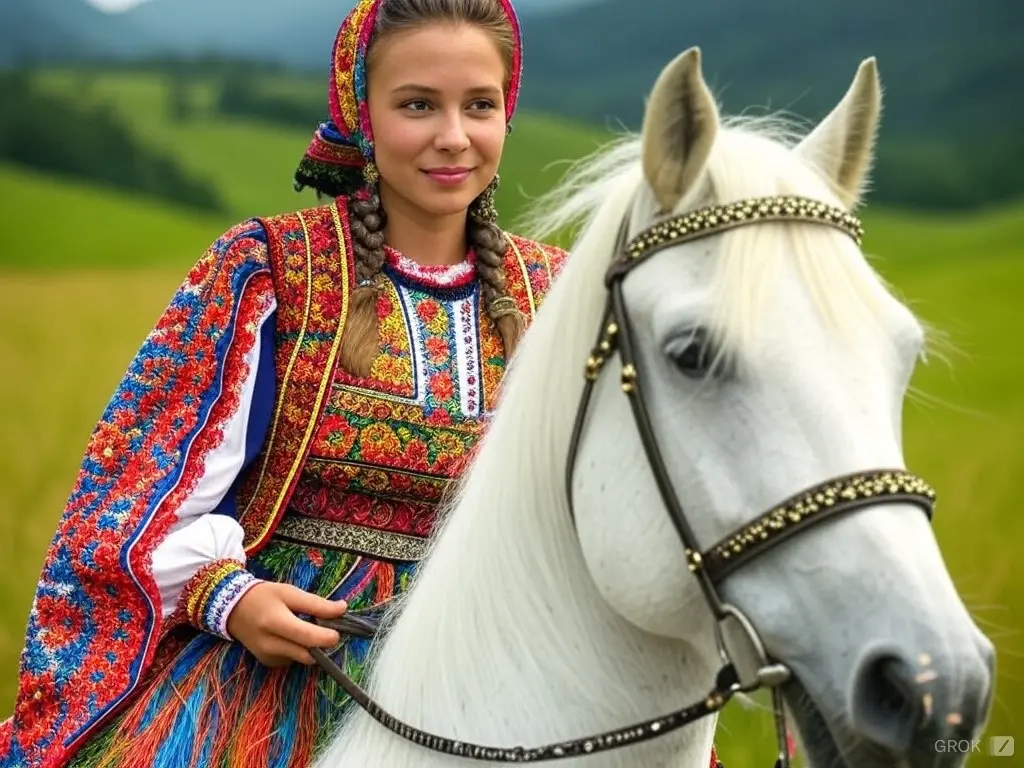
top-left (227, 582), bottom-right (348, 667)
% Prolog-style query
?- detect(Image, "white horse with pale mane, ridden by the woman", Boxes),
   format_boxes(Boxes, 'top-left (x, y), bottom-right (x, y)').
top-left (319, 49), bottom-right (994, 768)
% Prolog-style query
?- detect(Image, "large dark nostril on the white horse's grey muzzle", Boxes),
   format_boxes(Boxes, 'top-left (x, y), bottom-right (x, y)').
top-left (851, 655), bottom-right (928, 754)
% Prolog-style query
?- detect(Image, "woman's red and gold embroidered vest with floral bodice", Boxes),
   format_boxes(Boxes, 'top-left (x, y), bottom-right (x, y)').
top-left (238, 200), bottom-right (564, 560)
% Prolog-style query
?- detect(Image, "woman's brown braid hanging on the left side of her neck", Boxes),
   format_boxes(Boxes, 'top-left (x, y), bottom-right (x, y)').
top-left (339, 184), bottom-right (387, 376)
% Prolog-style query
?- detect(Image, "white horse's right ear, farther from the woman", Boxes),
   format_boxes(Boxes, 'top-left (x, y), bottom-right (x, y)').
top-left (797, 56), bottom-right (882, 208)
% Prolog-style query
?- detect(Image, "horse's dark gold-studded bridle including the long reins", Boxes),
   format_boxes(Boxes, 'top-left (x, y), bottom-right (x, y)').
top-left (310, 197), bottom-right (935, 768)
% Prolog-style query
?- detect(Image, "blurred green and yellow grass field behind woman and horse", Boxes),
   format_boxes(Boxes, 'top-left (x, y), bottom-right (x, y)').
top-left (0, 70), bottom-right (1024, 768)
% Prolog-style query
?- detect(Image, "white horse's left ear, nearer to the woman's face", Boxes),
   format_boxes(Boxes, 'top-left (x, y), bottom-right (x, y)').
top-left (643, 47), bottom-right (719, 211)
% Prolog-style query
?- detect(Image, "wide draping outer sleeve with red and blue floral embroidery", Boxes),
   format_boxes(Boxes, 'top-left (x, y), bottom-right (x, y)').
top-left (0, 222), bottom-right (273, 768)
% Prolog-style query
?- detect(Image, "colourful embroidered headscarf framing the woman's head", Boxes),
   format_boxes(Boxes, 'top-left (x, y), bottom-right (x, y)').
top-left (295, 0), bottom-right (522, 197)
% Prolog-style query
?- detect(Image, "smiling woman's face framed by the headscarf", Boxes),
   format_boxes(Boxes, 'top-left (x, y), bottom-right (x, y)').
top-left (367, 24), bottom-right (506, 224)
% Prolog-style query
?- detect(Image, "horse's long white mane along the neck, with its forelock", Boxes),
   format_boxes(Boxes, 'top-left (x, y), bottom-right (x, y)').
top-left (321, 115), bottom-right (933, 768)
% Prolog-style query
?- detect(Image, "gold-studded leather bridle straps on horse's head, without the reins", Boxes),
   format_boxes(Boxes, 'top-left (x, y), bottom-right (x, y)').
top-left (565, 197), bottom-right (935, 768)
